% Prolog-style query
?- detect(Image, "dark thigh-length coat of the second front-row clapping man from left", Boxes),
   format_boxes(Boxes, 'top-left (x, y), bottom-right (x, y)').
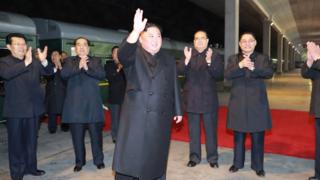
top-left (61, 56), bottom-right (105, 123)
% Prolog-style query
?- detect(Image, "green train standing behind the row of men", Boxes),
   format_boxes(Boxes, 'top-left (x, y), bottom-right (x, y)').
top-left (0, 11), bottom-right (190, 122)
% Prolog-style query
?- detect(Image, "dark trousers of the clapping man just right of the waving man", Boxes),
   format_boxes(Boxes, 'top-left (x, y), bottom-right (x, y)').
top-left (188, 112), bottom-right (218, 163)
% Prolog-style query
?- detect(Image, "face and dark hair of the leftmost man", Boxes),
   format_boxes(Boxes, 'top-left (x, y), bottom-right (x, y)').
top-left (7, 37), bottom-right (27, 59)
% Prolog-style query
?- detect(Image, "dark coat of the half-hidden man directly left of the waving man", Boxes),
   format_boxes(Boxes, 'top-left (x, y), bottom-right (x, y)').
top-left (104, 61), bottom-right (126, 104)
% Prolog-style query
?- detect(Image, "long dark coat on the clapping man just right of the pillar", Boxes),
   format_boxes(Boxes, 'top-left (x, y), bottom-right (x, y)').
top-left (225, 52), bottom-right (273, 132)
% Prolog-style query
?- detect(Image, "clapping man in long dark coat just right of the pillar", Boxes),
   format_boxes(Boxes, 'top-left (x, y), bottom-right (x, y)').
top-left (225, 33), bottom-right (273, 176)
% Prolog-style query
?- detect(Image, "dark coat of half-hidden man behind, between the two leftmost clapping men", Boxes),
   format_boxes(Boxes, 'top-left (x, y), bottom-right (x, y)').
top-left (45, 69), bottom-right (66, 114)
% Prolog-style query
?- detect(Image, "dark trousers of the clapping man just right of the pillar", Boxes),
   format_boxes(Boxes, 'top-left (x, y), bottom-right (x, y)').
top-left (233, 131), bottom-right (265, 171)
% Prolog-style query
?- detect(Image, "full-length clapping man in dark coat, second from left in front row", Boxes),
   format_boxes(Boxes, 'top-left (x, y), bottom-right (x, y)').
top-left (61, 37), bottom-right (105, 172)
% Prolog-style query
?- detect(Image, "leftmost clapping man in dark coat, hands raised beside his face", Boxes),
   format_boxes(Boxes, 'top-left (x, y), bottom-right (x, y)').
top-left (0, 33), bottom-right (53, 180)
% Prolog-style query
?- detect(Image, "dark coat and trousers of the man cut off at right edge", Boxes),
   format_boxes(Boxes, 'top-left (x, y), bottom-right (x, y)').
top-left (301, 60), bottom-right (320, 179)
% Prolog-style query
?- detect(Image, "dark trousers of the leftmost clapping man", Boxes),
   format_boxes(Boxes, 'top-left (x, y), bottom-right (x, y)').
top-left (7, 117), bottom-right (39, 179)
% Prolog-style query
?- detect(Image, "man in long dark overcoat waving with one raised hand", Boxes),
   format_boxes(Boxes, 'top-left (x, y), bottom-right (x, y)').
top-left (112, 9), bottom-right (182, 180)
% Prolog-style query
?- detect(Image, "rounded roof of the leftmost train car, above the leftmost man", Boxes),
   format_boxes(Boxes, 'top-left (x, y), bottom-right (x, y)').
top-left (0, 11), bottom-right (36, 35)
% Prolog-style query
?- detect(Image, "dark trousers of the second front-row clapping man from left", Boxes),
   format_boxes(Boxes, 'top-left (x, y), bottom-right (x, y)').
top-left (69, 123), bottom-right (103, 166)
